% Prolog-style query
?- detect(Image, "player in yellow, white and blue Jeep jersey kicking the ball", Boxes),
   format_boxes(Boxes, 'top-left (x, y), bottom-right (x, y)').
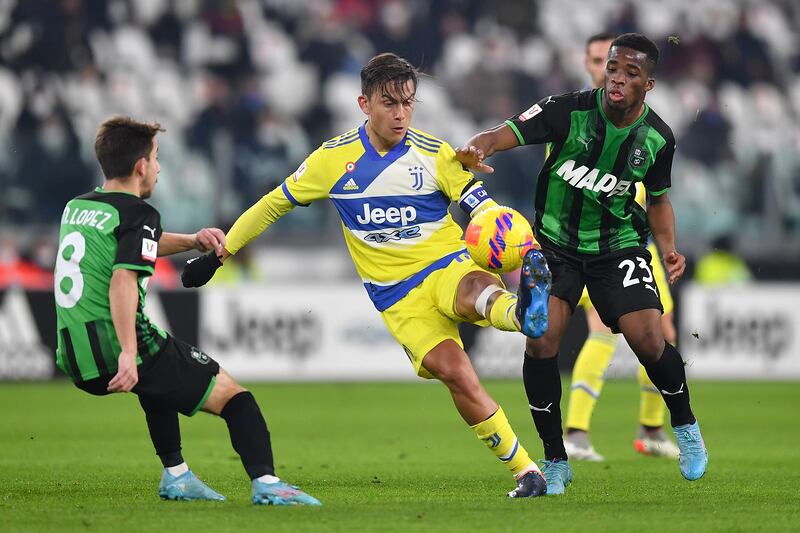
top-left (183, 53), bottom-right (546, 498)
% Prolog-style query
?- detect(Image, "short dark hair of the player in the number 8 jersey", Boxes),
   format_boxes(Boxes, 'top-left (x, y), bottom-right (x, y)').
top-left (94, 115), bottom-right (165, 179)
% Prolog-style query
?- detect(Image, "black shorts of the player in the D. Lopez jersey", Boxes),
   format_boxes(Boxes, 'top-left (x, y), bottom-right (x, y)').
top-left (75, 336), bottom-right (219, 416)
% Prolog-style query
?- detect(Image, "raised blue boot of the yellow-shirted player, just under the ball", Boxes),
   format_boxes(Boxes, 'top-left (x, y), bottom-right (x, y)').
top-left (517, 248), bottom-right (553, 339)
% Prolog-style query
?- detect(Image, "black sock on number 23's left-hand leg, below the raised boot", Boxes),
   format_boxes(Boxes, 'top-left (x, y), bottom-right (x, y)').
top-left (522, 355), bottom-right (567, 461)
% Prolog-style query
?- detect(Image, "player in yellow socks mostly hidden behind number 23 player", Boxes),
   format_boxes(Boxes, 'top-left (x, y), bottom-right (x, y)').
top-left (564, 32), bottom-right (679, 461)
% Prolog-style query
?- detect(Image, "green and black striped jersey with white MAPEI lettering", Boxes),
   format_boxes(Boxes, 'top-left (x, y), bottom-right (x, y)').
top-left (506, 89), bottom-right (675, 255)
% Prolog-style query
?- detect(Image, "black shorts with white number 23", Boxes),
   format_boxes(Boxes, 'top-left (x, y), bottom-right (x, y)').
top-left (540, 235), bottom-right (664, 333)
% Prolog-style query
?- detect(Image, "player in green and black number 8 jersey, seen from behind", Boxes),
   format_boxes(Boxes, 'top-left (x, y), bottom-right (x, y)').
top-left (55, 117), bottom-right (319, 505)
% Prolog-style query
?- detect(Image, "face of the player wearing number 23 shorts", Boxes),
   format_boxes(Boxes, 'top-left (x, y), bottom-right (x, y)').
top-left (605, 46), bottom-right (655, 111)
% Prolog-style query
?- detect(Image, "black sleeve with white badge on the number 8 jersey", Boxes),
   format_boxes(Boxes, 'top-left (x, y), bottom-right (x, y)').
top-left (112, 204), bottom-right (161, 275)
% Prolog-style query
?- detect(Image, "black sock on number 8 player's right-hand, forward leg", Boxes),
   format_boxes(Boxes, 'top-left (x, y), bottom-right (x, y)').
top-left (220, 391), bottom-right (275, 479)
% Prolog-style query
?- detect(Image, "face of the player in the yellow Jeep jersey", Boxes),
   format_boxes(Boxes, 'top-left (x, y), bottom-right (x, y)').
top-left (358, 80), bottom-right (416, 150)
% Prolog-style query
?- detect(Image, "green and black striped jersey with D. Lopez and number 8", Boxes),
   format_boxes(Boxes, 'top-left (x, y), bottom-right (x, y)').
top-left (55, 187), bottom-right (167, 382)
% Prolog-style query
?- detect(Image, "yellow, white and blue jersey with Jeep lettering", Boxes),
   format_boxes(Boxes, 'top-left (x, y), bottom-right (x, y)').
top-left (253, 125), bottom-right (478, 311)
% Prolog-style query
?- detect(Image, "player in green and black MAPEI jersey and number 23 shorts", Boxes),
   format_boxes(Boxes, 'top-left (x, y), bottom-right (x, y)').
top-left (457, 34), bottom-right (708, 494)
